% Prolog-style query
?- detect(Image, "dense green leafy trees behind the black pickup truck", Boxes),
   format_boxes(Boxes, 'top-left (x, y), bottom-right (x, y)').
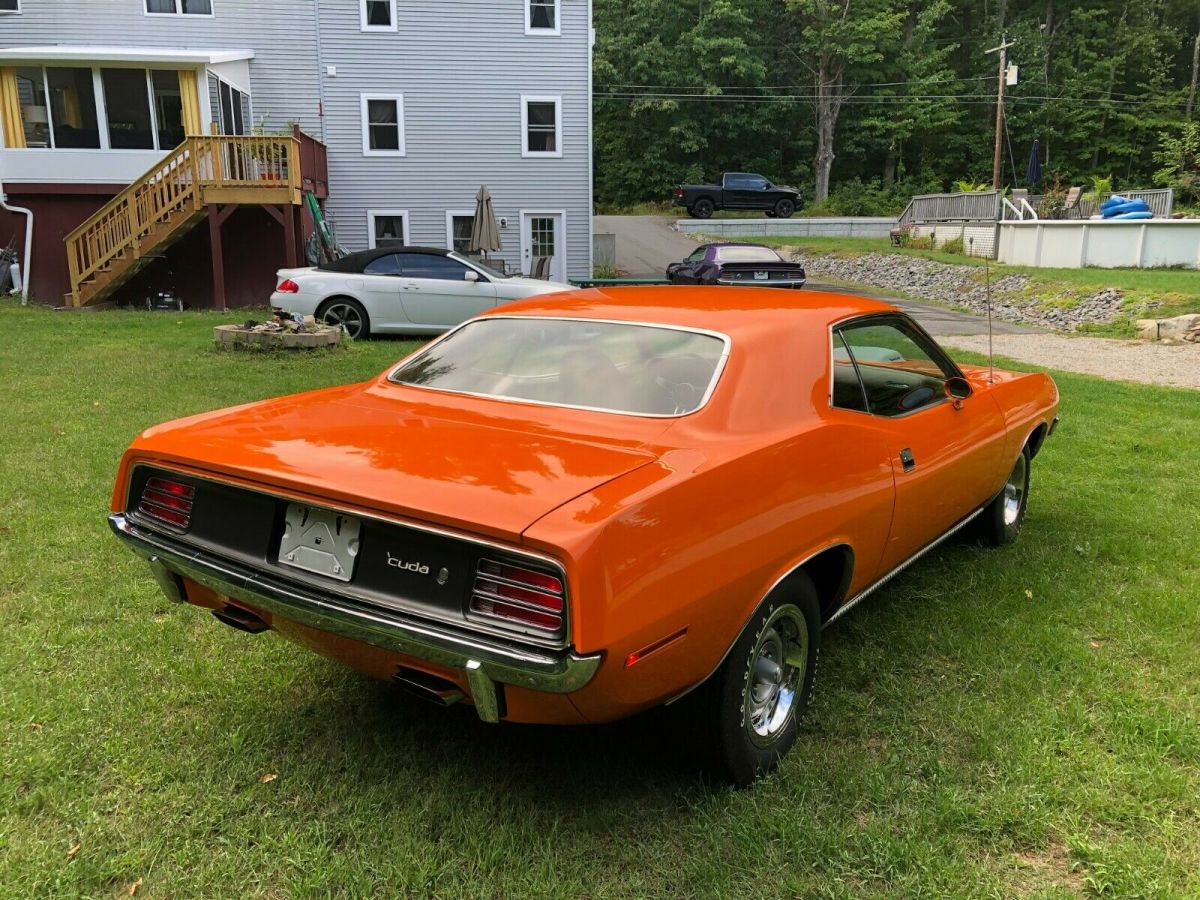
top-left (594, 0), bottom-right (1200, 215)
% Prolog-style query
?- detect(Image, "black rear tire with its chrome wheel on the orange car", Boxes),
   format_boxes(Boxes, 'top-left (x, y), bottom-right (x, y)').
top-left (680, 572), bottom-right (821, 787)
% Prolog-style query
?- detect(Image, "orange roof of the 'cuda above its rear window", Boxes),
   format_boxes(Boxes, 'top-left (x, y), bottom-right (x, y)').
top-left (484, 284), bottom-right (898, 341)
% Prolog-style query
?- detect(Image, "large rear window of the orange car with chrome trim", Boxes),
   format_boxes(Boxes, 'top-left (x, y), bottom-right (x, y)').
top-left (391, 317), bottom-right (728, 416)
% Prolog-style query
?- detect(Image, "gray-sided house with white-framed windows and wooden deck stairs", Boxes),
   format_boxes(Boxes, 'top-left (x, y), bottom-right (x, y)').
top-left (0, 0), bottom-right (592, 305)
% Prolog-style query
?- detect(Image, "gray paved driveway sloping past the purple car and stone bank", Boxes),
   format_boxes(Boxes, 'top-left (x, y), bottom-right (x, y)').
top-left (593, 216), bottom-right (1037, 336)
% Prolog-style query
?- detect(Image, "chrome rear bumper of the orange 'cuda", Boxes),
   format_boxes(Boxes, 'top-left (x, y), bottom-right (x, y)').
top-left (108, 515), bottom-right (601, 722)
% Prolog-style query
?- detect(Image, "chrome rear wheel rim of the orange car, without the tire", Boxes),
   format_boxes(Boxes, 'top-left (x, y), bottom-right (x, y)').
top-left (743, 605), bottom-right (809, 746)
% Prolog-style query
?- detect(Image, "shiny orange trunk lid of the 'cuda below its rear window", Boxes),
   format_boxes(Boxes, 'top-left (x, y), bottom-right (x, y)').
top-left (133, 388), bottom-right (655, 541)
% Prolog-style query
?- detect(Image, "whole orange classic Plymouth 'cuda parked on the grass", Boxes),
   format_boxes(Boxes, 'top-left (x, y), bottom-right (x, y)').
top-left (109, 287), bottom-right (1058, 784)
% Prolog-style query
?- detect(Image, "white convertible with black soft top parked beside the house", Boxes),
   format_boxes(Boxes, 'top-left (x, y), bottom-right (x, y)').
top-left (271, 247), bottom-right (572, 338)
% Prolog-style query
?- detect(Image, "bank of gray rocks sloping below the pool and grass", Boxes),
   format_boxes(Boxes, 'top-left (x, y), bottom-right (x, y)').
top-left (784, 251), bottom-right (1123, 331)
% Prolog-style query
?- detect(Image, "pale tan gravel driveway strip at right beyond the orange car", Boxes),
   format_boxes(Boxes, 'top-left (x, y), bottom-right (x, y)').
top-left (940, 334), bottom-right (1200, 390)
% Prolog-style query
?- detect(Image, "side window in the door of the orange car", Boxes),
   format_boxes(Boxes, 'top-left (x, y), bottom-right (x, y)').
top-left (833, 319), bottom-right (958, 418)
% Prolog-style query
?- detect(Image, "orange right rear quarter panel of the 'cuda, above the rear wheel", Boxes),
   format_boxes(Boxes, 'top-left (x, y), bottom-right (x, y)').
top-left (524, 324), bottom-right (894, 721)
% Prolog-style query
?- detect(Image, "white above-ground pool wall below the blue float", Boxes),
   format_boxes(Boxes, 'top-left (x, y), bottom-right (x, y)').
top-left (998, 218), bottom-right (1200, 269)
